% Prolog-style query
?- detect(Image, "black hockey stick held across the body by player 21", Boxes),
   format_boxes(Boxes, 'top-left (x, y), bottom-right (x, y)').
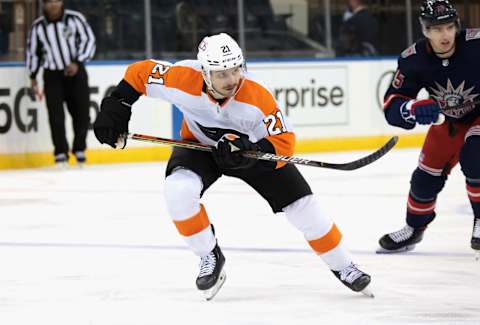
top-left (124, 133), bottom-right (398, 170)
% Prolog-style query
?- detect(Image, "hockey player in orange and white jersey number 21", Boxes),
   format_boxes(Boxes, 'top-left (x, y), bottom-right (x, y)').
top-left (94, 33), bottom-right (371, 300)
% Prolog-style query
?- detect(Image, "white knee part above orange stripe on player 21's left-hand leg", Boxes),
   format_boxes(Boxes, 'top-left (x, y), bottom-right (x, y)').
top-left (165, 169), bottom-right (203, 220)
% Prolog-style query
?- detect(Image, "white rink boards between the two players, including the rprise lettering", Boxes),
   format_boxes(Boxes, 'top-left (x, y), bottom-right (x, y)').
top-left (248, 60), bottom-right (428, 139)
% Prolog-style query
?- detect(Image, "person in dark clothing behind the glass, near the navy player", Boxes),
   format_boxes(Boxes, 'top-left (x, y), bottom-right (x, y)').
top-left (336, 0), bottom-right (378, 56)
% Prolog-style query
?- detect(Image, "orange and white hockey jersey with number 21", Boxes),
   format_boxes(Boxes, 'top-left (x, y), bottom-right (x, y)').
top-left (124, 60), bottom-right (295, 161)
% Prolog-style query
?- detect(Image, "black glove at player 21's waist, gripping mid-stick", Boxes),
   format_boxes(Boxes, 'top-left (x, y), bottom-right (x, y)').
top-left (212, 133), bottom-right (258, 169)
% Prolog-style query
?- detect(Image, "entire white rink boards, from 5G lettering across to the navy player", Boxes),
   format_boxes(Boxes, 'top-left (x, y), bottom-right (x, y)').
top-left (0, 60), bottom-right (423, 154)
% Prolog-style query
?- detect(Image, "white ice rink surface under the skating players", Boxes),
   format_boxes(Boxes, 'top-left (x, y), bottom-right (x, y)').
top-left (0, 149), bottom-right (480, 325)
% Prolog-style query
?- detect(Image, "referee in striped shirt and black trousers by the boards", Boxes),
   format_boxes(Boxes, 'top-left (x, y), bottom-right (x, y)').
top-left (26, 0), bottom-right (95, 167)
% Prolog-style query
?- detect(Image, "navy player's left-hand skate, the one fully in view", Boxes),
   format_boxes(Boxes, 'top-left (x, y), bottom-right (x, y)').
top-left (377, 225), bottom-right (425, 254)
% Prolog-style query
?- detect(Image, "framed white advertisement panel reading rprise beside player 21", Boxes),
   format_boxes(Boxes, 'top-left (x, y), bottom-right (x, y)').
top-left (249, 63), bottom-right (349, 128)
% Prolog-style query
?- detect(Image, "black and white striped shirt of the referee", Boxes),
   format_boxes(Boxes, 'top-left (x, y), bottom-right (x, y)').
top-left (26, 9), bottom-right (96, 79)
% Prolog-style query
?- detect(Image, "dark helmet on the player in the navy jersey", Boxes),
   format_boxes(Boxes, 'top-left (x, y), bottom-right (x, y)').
top-left (420, 0), bottom-right (460, 28)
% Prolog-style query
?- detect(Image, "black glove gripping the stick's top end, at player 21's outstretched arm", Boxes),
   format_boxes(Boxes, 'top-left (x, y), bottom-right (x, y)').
top-left (93, 97), bottom-right (132, 149)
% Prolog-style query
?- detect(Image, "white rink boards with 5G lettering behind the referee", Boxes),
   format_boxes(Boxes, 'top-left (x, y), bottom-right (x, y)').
top-left (0, 65), bottom-right (172, 154)
